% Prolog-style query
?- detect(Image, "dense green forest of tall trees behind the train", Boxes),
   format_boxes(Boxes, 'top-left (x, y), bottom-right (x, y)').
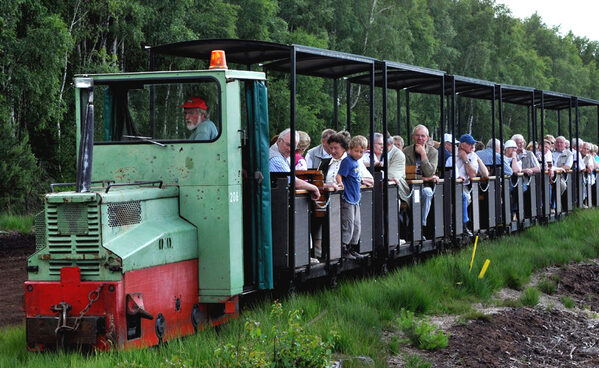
top-left (0, 0), bottom-right (599, 213)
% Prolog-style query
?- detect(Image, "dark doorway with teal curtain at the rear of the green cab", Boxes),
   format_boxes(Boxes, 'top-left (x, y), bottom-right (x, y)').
top-left (242, 80), bottom-right (273, 289)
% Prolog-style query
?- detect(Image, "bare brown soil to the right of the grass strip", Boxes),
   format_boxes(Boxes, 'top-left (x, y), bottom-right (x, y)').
top-left (389, 262), bottom-right (599, 367)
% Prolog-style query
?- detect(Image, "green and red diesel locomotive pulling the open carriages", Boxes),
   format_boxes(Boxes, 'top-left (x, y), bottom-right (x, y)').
top-left (25, 68), bottom-right (272, 350)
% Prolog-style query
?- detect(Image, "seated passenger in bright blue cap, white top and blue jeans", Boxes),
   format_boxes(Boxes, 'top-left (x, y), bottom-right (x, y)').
top-left (448, 134), bottom-right (489, 237)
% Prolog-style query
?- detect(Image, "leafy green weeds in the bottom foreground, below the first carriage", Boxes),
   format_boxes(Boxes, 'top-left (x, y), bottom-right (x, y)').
top-left (215, 302), bottom-right (336, 368)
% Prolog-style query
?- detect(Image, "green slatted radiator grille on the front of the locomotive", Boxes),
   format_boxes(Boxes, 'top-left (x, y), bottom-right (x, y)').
top-left (46, 202), bottom-right (100, 277)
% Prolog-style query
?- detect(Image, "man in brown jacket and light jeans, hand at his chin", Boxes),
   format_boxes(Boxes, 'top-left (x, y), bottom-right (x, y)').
top-left (403, 124), bottom-right (439, 226)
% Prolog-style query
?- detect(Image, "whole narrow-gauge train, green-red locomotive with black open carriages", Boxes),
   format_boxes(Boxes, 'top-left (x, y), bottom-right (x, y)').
top-left (24, 40), bottom-right (599, 350)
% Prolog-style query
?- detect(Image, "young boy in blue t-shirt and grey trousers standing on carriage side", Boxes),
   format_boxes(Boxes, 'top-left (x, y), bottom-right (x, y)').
top-left (336, 135), bottom-right (368, 259)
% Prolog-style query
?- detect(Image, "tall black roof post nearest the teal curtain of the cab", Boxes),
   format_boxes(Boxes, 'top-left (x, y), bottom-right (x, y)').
top-left (289, 46), bottom-right (297, 274)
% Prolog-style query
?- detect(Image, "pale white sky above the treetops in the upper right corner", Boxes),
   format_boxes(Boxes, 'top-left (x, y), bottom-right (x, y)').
top-left (497, 0), bottom-right (599, 41)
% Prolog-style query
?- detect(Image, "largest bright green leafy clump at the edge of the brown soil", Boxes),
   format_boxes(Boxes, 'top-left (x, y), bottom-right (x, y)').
top-left (397, 308), bottom-right (449, 350)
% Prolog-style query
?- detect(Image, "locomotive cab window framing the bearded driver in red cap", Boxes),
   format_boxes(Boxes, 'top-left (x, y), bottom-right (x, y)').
top-left (88, 78), bottom-right (221, 144)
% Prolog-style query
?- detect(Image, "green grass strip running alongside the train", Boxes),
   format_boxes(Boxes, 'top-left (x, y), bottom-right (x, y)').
top-left (0, 210), bottom-right (599, 367)
